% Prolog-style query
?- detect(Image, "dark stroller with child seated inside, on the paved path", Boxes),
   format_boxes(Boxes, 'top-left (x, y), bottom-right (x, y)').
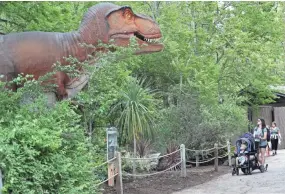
top-left (232, 133), bottom-right (268, 175)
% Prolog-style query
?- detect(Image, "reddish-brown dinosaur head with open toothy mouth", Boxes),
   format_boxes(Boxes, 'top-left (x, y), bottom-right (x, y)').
top-left (79, 3), bottom-right (163, 54)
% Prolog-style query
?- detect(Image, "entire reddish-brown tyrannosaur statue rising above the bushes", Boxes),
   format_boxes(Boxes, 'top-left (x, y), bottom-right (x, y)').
top-left (0, 3), bottom-right (163, 99)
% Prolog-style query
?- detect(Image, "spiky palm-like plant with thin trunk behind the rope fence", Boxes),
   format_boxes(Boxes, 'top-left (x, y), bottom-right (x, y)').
top-left (112, 77), bottom-right (155, 175)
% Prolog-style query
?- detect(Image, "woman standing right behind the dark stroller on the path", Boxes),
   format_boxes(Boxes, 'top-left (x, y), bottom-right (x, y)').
top-left (253, 119), bottom-right (267, 172)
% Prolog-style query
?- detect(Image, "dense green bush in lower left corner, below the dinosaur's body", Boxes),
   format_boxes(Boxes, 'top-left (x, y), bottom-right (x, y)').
top-left (0, 81), bottom-right (96, 194)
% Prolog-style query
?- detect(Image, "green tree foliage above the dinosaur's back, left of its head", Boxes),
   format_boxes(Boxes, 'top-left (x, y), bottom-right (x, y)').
top-left (0, 2), bottom-right (96, 34)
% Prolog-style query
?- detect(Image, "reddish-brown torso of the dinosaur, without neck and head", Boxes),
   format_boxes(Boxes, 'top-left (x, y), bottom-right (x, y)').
top-left (0, 32), bottom-right (83, 96)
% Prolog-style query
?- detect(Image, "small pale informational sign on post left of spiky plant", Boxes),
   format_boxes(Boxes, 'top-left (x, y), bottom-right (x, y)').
top-left (107, 127), bottom-right (118, 160)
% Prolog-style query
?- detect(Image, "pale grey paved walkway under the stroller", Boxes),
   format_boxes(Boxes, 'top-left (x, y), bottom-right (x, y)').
top-left (173, 150), bottom-right (285, 194)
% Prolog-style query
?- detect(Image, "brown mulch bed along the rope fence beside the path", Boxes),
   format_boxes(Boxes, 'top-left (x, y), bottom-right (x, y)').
top-left (102, 166), bottom-right (231, 194)
